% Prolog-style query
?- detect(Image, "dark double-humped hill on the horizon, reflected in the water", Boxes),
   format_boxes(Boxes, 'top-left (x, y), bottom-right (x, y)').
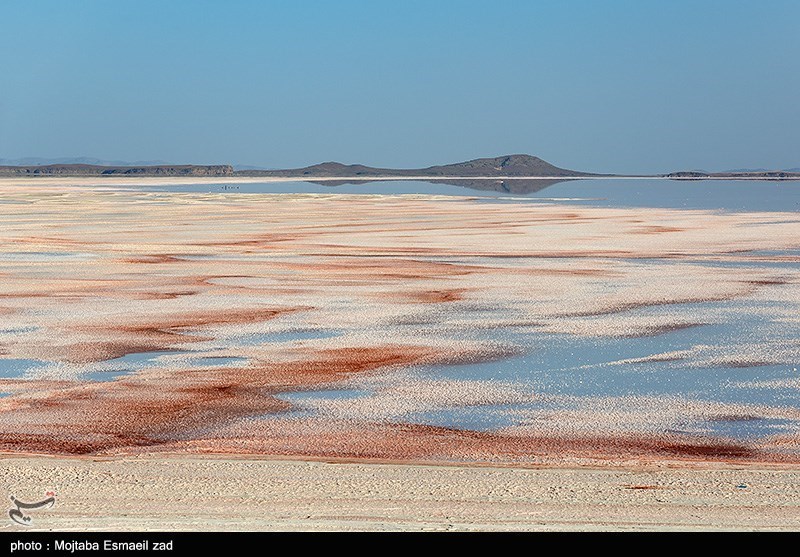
top-left (236, 155), bottom-right (599, 178)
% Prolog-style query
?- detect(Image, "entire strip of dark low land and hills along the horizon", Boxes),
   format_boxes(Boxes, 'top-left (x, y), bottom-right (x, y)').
top-left (0, 155), bottom-right (800, 180)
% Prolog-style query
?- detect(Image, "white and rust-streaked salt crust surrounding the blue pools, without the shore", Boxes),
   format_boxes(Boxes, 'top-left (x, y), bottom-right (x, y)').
top-left (0, 187), bottom-right (800, 464)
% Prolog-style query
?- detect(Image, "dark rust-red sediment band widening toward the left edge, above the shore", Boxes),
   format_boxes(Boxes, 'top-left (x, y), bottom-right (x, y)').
top-left (0, 346), bottom-right (436, 454)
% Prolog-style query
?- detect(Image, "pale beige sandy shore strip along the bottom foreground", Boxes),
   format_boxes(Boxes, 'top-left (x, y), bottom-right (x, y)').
top-left (0, 457), bottom-right (800, 532)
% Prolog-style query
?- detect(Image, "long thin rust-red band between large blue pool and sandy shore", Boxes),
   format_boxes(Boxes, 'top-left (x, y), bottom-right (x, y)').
top-left (150, 419), bottom-right (780, 465)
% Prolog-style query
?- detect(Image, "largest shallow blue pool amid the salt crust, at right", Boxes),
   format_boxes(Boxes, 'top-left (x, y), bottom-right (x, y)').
top-left (282, 286), bottom-right (800, 441)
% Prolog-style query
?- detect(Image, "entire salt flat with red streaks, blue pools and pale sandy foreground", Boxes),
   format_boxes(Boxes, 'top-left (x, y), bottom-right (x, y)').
top-left (0, 182), bottom-right (800, 529)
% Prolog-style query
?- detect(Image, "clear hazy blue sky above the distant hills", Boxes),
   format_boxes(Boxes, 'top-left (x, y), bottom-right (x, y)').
top-left (0, 0), bottom-right (800, 172)
